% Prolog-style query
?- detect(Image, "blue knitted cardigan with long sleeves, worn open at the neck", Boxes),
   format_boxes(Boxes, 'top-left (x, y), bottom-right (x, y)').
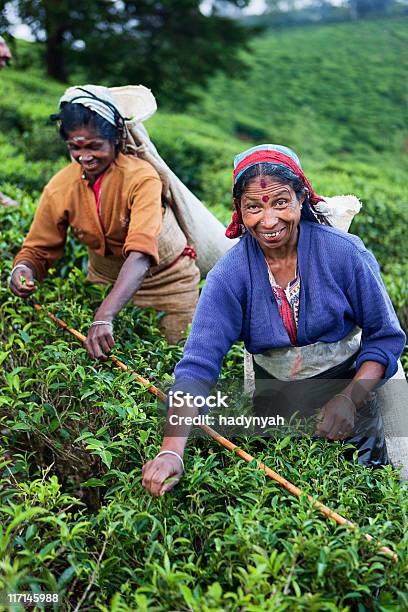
top-left (172, 221), bottom-right (405, 394)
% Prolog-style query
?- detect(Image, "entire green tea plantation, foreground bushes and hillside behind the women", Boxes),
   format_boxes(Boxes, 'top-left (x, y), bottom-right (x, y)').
top-left (0, 20), bottom-right (408, 612)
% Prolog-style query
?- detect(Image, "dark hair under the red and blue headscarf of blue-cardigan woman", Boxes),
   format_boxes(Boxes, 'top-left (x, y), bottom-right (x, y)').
top-left (233, 163), bottom-right (330, 225)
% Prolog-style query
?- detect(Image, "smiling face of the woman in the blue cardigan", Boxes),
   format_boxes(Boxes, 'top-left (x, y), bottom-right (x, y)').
top-left (241, 176), bottom-right (305, 254)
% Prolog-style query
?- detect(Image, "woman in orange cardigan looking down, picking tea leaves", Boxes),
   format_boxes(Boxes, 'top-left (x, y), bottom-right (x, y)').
top-left (10, 85), bottom-right (200, 359)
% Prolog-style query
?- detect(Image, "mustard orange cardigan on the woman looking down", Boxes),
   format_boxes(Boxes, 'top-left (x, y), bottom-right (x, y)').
top-left (14, 153), bottom-right (162, 280)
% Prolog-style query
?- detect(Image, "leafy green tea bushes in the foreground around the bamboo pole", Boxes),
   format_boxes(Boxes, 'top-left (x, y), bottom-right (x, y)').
top-left (0, 151), bottom-right (408, 610)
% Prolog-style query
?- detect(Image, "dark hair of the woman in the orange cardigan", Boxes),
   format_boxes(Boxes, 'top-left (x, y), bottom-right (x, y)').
top-left (50, 102), bottom-right (123, 153)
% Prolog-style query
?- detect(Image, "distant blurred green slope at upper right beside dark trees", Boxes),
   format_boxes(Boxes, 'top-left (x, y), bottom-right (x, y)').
top-left (190, 18), bottom-right (408, 159)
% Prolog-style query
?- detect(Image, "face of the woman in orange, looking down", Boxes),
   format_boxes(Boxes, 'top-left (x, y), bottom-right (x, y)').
top-left (66, 126), bottom-right (116, 180)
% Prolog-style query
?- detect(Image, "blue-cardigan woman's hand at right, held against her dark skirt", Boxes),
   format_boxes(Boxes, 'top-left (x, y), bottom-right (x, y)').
top-left (316, 395), bottom-right (356, 440)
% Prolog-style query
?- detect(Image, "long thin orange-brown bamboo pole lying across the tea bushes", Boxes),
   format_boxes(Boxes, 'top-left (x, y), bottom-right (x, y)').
top-left (34, 304), bottom-right (398, 561)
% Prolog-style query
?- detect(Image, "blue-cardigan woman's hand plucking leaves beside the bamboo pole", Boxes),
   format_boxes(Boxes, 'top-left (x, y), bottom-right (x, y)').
top-left (142, 453), bottom-right (183, 497)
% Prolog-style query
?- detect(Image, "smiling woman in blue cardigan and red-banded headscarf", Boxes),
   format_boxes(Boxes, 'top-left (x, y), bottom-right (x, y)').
top-left (143, 145), bottom-right (405, 496)
